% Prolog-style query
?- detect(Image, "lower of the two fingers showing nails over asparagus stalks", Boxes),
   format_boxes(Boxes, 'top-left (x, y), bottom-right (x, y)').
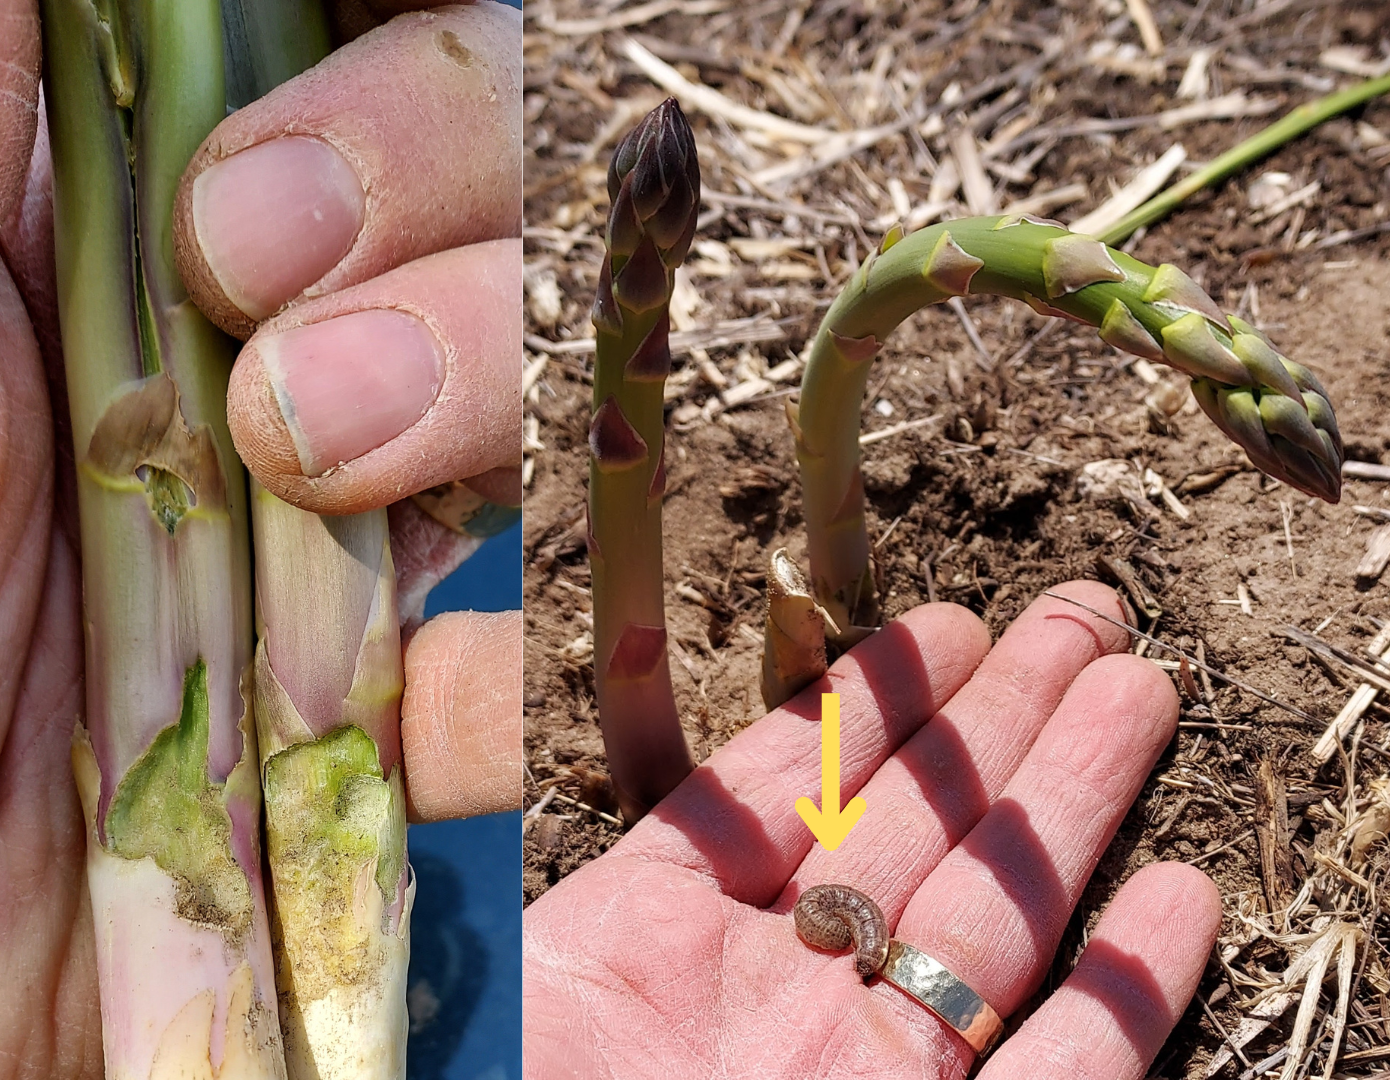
top-left (227, 240), bottom-right (521, 514)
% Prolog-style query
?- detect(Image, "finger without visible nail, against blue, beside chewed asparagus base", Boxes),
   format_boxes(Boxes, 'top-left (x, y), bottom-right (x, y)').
top-left (400, 612), bottom-right (521, 821)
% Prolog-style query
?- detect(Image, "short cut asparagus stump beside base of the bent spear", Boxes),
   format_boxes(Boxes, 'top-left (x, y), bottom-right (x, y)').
top-left (762, 548), bottom-right (840, 709)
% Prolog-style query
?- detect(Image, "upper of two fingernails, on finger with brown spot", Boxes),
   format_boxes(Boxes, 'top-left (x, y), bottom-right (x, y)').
top-left (193, 136), bottom-right (366, 321)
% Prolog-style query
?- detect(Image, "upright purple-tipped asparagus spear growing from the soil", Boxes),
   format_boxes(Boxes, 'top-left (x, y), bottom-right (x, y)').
top-left (588, 99), bottom-right (699, 823)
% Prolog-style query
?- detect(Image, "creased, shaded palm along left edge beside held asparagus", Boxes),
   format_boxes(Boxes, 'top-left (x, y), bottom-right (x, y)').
top-left (0, 0), bottom-right (101, 1080)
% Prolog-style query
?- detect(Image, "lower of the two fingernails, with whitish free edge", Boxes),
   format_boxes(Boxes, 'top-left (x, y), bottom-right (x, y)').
top-left (254, 309), bottom-right (443, 477)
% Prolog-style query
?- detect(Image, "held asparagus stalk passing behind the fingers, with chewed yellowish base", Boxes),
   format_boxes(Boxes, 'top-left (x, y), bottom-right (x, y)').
top-left (224, 0), bottom-right (416, 1080)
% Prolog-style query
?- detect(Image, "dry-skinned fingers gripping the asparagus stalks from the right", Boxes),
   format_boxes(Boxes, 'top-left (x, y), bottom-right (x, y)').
top-left (166, 0), bottom-right (521, 819)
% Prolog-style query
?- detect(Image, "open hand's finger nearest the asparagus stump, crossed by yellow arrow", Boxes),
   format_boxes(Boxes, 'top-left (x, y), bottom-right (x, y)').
top-left (617, 603), bottom-right (990, 906)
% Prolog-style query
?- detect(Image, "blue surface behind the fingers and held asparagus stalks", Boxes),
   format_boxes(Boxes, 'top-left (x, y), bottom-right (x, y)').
top-left (406, 523), bottom-right (521, 1080)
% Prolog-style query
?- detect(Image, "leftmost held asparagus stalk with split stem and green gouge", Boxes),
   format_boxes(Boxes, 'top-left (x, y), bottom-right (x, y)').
top-left (43, 0), bottom-right (285, 1080)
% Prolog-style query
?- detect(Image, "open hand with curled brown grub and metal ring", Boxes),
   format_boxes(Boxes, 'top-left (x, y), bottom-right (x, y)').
top-left (523, 582), bottom-right (1220, 1080)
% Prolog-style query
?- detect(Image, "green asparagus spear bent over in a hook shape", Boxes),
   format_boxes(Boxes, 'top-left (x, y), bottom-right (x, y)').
top-left (788, 215), bottom-right (1343, 628)
